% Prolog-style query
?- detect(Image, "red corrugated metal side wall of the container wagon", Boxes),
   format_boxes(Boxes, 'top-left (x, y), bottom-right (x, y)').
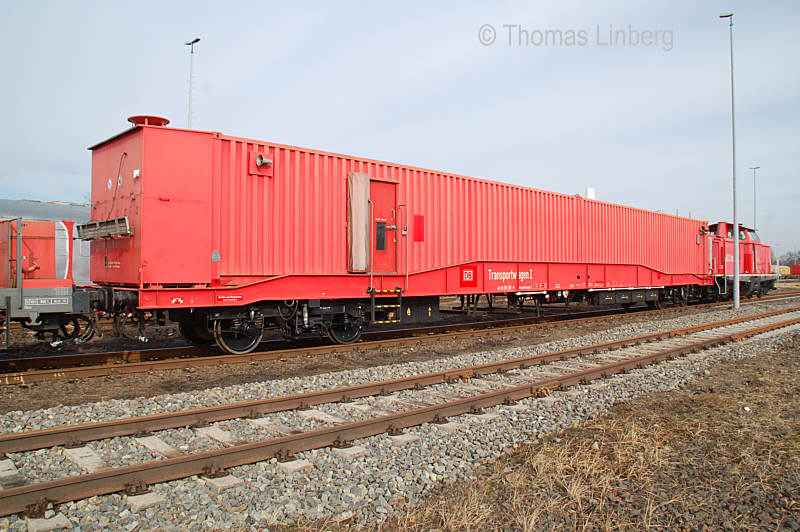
top-left (212, 136), bottom-right (705, 277)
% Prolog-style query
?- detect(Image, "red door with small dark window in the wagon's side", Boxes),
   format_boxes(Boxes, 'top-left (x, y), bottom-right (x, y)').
top-left (376, 181), bottom-right (397, 273)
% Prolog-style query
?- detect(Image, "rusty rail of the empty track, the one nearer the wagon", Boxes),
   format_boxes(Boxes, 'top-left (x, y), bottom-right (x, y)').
top-left (0, 307), bottom-right (800, 455)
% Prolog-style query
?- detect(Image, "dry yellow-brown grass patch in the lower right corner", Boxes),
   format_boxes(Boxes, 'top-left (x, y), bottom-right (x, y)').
top-left (280, 333), bottom-right (800, 532)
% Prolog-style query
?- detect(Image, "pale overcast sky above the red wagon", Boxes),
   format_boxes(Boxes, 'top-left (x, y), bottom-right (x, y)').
top-left (0, 0), bottom-right (800, 253)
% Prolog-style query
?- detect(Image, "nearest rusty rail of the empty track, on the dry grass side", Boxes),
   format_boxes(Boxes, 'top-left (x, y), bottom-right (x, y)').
top-left (0, 318), bottom-right (800, 515)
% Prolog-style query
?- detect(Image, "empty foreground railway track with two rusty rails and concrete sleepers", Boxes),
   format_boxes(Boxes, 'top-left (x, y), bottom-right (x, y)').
top-left (0, 307), bottom-right (800, 515)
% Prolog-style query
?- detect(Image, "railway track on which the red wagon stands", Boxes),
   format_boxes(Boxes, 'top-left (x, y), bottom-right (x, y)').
top-left (0, 291), bottom-right (800, 386)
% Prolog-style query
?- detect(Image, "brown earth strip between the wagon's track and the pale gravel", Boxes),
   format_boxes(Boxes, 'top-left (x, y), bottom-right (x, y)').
top-left (0, 298), bottom-right (800, 413)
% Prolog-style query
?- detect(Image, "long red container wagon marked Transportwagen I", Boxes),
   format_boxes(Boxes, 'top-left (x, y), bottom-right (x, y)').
top-left (79, 116), bottom-right (776, 352)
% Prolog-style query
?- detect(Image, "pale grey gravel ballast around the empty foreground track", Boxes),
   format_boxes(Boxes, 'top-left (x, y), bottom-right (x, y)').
top-left (0, 302), bottom-right (800, 530)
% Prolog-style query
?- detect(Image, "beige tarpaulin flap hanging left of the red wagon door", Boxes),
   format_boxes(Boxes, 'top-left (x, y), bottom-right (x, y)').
top-left (347, 172), bottom-right (370, 272)
